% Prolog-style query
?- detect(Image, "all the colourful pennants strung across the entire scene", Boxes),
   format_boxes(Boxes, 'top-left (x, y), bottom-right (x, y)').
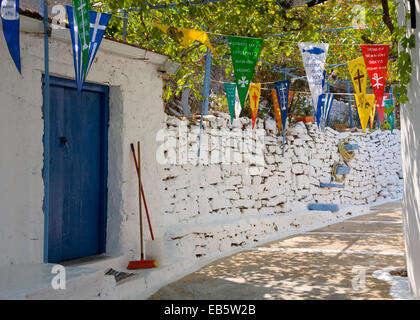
top-left (1, 0), bottom-right (394, 134)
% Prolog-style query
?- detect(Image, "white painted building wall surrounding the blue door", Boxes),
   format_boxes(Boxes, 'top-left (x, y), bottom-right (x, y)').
top-left (0, 16), bottom-right (166, 265)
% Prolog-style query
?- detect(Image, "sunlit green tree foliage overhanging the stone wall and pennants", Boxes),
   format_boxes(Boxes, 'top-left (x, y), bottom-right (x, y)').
top-left (91, 0), bottom-right (414, 102)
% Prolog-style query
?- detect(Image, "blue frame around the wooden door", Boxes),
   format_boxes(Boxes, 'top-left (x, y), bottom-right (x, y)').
top-left (42, 74), bottom-right (109, 263)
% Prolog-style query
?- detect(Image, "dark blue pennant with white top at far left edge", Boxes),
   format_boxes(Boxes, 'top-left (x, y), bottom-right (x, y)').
top-left (1, 0), bottom-right (22, 73)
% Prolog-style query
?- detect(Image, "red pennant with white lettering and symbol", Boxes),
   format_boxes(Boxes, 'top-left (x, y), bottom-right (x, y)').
top-left (361, 45), bottom-right (389, 123)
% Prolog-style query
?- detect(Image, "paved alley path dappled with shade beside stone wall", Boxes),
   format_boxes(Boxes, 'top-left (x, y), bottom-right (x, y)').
top-left (149, 202), bottom-right (405, 300)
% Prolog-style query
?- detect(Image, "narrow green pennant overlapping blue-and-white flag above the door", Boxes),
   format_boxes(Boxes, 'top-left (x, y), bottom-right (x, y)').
top-left (69, 0), bottom-right (90, 77)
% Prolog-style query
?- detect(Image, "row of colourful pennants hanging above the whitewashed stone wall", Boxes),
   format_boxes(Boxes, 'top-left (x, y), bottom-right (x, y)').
top-left (220, 36), bottom-right (393, 135)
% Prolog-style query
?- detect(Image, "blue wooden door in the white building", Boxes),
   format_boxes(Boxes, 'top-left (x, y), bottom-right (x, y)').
top-left (47, 77), bottom-right (108, 263)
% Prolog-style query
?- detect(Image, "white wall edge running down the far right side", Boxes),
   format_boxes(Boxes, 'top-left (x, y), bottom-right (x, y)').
top-left (399, 1), bottom-right (420, 299)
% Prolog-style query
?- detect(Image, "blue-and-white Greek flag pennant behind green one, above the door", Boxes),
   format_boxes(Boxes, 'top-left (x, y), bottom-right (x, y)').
top-left (66, 6), bottom-right (111, 92)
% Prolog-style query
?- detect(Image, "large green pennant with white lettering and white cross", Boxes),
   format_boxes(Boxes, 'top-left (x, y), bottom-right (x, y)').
top-left (228, 36), bottom-right (263, 108)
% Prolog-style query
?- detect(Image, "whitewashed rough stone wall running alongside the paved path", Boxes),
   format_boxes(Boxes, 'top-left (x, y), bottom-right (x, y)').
top-left (157, 113), bottom-right (402, 258)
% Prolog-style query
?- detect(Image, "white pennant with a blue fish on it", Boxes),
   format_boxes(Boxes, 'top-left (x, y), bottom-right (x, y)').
top-left (298, 42), bottom-right (329, 114)
